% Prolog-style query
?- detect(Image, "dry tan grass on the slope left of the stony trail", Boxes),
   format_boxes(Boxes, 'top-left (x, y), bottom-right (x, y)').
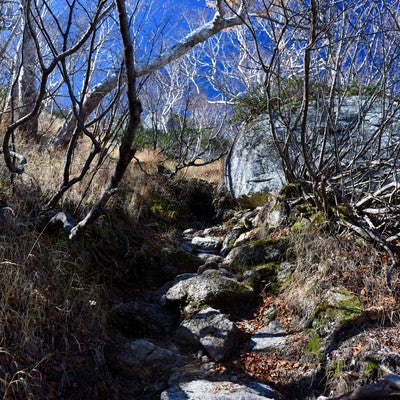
top-left (0, 112), bottom-right (228, 399)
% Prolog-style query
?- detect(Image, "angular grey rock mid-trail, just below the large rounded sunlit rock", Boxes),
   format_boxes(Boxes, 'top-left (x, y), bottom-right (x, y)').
top-left (176, 307), bottom-right (242, 361)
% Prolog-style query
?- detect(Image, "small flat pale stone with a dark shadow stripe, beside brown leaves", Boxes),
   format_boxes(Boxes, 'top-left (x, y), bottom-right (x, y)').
top-left (250, 320), bottom-right (286, 351)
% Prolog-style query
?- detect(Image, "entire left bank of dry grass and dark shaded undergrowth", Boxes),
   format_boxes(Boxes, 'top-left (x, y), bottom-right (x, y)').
top-left (0, 127), bottom-right (225, 400)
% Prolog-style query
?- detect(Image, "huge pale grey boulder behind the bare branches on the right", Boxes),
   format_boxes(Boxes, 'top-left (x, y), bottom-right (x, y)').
top-left (225, 96), bottom-right (400, 199)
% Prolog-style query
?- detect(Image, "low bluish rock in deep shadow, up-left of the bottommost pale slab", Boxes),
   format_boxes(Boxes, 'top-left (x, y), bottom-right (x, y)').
top-left (104, 339), bottom-right (182, 380)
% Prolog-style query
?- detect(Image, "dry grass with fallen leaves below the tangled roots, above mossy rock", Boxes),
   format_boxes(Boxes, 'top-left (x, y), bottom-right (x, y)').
top-left (284, 225), bottom-right (400, 324)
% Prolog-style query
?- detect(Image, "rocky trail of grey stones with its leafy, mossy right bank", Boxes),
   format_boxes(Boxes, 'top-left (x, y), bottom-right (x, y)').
top-left (98, 191), bottom-right (400, 400)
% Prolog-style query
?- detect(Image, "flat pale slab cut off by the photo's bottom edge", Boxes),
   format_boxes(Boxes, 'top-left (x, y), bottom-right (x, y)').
top-left (161, 379), bottom-right (280, 400)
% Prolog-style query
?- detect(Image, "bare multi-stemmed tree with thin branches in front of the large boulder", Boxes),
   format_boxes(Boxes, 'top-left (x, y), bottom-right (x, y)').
top-left (234, 0), bottom-right (400, 292)
